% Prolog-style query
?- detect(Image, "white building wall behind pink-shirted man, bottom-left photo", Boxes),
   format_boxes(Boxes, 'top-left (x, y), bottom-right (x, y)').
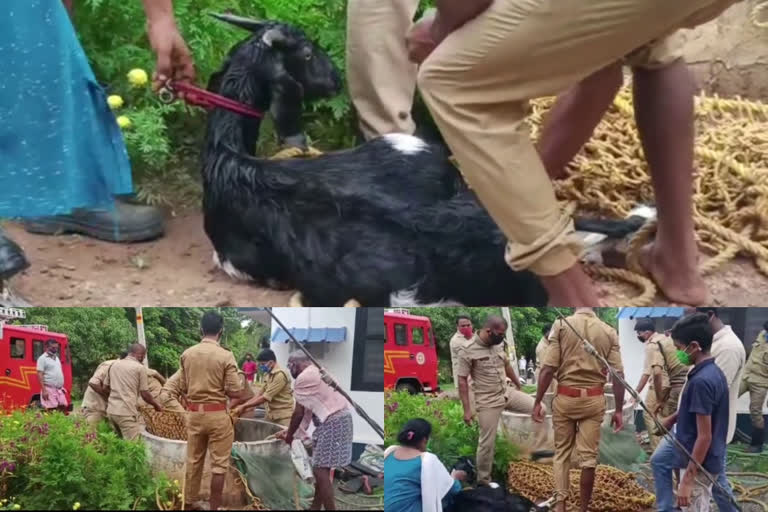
top-left (270, 308), bottom-right (384, 444)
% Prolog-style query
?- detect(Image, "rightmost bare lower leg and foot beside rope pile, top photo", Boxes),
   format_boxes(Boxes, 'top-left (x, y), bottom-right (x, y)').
top-left (632, 37), bottom-right (709, 305)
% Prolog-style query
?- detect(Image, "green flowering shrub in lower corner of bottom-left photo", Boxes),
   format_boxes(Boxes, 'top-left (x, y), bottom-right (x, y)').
top-left (0, 409), bottom-right (179, 510)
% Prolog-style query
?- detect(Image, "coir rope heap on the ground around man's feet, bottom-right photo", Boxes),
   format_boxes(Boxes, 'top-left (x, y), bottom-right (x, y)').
top-left (508, 462), bottom-right (655, 512)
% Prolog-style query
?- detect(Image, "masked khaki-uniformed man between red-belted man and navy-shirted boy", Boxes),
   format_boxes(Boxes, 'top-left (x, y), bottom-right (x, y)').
top-left (635, 318), bottom-right (690, 451)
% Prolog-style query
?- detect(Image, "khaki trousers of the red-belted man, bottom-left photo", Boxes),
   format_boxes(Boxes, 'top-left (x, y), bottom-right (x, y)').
top-left (185, 411), bottom-right (235, 503)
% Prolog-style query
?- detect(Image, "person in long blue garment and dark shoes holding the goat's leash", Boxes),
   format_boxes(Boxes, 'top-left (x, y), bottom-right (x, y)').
top-left (0, 0), bottom-right (194, 303)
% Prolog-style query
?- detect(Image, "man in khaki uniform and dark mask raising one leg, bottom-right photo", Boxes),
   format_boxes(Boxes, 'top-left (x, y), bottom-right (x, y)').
top-left (458, 316), bottom-right (551, 485)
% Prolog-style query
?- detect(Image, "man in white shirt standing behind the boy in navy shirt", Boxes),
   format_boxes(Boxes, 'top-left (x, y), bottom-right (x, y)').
top-left (696, 307), bottom-right (747, 510)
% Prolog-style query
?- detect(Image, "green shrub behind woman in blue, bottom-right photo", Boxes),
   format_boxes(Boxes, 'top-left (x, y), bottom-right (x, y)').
top-left (384, 392), bottom-right (519, 482)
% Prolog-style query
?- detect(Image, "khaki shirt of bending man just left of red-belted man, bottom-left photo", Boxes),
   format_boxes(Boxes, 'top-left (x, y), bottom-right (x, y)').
top-left (105, 356), bottom-right (149, 416)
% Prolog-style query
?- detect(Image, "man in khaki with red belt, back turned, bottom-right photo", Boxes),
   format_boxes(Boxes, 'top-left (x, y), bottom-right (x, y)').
top-left (533, 308), bottom-right (624, 512)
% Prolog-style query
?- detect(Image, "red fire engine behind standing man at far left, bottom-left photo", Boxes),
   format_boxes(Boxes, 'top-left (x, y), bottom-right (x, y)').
top-left (0, 308), bottom-right (72, 410)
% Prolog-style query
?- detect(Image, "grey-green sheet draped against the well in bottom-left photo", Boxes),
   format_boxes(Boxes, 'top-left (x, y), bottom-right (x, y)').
top-left (232, 443), bottom-right (315, 510)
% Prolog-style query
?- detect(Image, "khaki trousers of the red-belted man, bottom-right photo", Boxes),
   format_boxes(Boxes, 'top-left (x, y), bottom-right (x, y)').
top-left (552, 395), bottom-right (605, 502)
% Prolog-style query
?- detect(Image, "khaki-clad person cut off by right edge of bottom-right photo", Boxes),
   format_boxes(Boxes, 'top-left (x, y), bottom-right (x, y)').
top-left (739, 322), bottom-right (768, 453)
